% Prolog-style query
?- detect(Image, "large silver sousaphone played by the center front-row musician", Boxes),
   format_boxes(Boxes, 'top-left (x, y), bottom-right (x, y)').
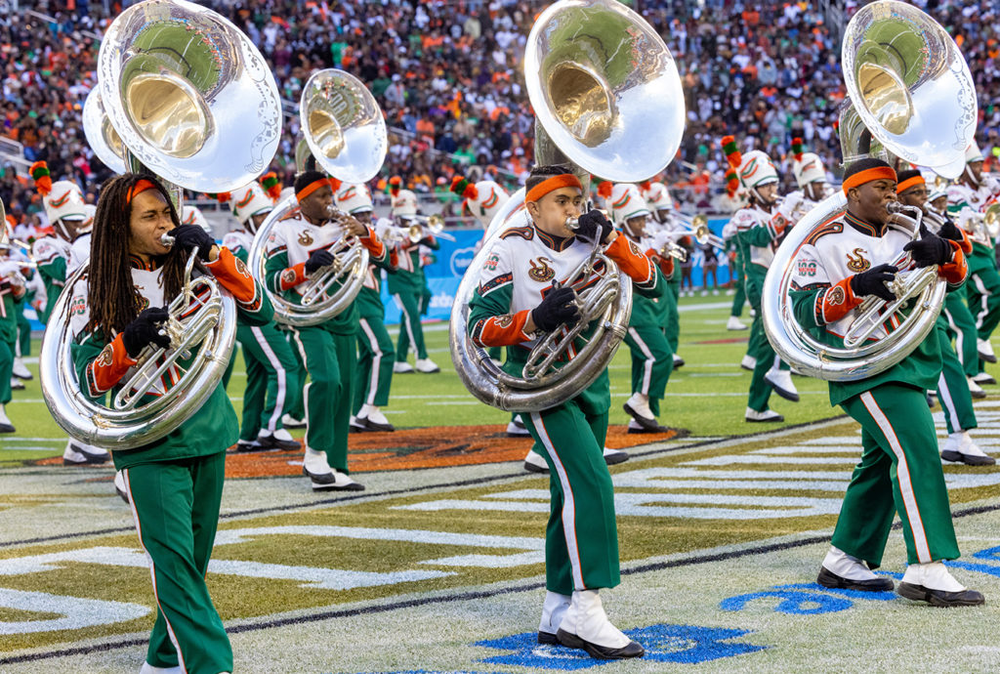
top-left (450, 0), bottom-right (685, 412)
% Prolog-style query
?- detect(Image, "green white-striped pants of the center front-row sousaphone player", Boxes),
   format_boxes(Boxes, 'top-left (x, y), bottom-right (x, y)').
top-left (521, 399), bottom-right (620, 595)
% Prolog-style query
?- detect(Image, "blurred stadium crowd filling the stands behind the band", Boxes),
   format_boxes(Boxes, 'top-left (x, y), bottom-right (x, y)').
top-left (0, 0), bottom-right (1000, 228)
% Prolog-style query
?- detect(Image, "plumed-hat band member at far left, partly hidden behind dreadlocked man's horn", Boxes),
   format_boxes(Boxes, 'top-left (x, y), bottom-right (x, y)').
top-left (30, 162), bottom-right (111, 466)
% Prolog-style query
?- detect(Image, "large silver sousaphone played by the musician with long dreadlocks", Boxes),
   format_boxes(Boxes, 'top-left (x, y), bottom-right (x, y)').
top-left (39, 0), bottom-right (281, 450)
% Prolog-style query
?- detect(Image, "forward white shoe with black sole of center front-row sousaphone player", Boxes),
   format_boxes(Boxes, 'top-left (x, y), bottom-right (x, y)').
top-left (556, 590), bottom-right (646, 660)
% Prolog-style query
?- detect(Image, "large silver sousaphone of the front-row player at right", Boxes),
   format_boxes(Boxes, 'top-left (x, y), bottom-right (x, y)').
top-left (761, 0), bottom-right (976, 381)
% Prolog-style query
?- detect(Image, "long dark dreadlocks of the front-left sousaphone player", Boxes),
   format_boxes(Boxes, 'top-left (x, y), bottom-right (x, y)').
top-left (86, 173), bottom-right (187, 343)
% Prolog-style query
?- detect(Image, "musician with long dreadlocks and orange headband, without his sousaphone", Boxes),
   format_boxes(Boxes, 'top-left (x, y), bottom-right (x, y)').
top-left (70, 173), bottom-right (273, 674)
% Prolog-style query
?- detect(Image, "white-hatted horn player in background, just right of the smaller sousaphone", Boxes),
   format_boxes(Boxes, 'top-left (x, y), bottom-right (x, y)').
top-left (388, 182), bottom-right (441, 374)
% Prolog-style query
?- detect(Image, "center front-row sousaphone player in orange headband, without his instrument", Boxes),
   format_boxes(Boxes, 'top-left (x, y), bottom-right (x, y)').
top-left (469, 166), bottom-right (666, 658)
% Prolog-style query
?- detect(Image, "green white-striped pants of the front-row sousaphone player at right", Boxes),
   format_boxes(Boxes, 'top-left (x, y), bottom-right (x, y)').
top-left (833, 382), bottom-right (960, 566)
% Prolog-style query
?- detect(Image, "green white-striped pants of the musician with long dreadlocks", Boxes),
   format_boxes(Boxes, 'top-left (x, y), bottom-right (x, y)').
top-left (122, 452), bottom-right (233, 674)
